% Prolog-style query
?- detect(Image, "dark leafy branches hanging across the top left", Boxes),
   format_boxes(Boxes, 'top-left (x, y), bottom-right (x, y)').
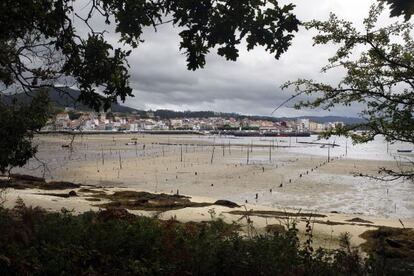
top-left (0, 0), bottom-right (300, 109)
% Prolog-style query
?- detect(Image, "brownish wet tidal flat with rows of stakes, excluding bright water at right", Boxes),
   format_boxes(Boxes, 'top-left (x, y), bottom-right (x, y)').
top-left (15, 135), bottom-right (414, 218)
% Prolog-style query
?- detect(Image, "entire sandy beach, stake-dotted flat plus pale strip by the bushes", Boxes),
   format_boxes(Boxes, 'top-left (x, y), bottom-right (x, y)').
top-left (6, 134), bottom-right (414, 247)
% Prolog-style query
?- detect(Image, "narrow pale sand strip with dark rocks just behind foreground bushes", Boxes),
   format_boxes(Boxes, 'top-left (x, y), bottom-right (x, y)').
top-left (4, 177), bottom-right (414, 249)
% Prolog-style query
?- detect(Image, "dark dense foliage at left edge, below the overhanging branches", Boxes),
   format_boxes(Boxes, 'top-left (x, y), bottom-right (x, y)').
top-left (0, 93), bottom-right (49, 173)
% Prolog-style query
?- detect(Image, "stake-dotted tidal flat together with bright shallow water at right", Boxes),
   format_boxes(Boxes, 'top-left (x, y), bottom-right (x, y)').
top-left (17, 135), bottom-right (414, 218)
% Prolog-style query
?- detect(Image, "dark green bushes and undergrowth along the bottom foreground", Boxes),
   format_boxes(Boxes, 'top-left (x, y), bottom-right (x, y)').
top-left (0, 204), bottom-right (408, 275)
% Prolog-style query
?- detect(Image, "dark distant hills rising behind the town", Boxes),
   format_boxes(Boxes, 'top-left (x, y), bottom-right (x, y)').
top-left (4, 87), bottom-right (364, 125)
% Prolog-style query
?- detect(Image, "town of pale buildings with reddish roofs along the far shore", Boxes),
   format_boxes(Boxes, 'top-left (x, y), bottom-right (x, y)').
top-left (42, 108), bottom-right (345, 136)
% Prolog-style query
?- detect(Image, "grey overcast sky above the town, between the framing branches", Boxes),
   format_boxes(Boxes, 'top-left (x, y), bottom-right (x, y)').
top-left (77, 0), bottom-right (398, 117)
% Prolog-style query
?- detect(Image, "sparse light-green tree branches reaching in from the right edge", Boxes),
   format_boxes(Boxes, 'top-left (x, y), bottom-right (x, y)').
top-left (283, 4), bottom-right (414, 179)
